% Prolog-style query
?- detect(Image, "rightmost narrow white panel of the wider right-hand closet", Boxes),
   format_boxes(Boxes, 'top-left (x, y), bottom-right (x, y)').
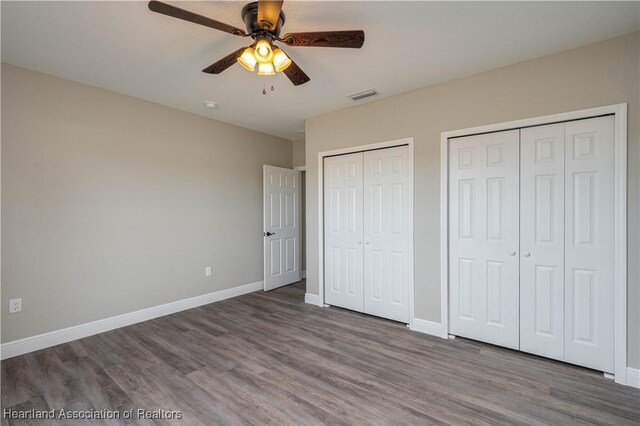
top-left (565, 116), bottom-right (615, 373)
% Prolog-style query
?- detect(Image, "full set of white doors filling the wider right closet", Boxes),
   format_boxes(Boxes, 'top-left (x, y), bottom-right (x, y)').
top-left (449, 116), bottom-right (615, 372)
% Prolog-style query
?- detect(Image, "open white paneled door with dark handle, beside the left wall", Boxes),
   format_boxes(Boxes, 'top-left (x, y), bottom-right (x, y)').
top-left (263, 166), bottom-right (300, 291)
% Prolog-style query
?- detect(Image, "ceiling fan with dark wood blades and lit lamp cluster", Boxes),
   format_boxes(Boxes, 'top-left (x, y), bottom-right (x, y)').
top-left (149, 0), bottom-right (364, 86)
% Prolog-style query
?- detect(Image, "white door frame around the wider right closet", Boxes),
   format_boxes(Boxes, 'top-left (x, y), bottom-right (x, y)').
top-left (439, 103), bottom-right (627, 384)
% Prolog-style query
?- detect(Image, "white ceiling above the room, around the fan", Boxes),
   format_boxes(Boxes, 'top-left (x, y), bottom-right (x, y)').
top-left (2, 0), bottom-right (640, 139)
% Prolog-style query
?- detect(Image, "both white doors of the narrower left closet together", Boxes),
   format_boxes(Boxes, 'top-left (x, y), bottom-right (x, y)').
top-left (324, 146), bottom-right (413, 322)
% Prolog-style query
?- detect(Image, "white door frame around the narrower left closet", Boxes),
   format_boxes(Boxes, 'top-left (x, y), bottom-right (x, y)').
top-left (318, 137), bottom-right (415, 328)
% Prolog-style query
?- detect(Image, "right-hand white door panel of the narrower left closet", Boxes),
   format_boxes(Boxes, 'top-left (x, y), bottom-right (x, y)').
top-left (364, 146), bottom-right (413, 323)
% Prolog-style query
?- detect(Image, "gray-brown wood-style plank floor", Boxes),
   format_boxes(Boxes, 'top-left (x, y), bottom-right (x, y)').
top-left (2, 283), bottom-right (640, 425)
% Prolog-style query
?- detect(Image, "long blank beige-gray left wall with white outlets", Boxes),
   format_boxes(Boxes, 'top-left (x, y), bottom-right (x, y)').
top-left (2, 64), bottom-right (292, 342)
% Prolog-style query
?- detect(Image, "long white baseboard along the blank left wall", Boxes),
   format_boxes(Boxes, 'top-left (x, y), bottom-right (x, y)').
top-left (0, 281), bottom-right (263, 359)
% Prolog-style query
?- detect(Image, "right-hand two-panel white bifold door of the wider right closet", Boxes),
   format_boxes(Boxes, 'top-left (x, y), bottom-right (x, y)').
top-left (520, 116), bottom-right (614, 372)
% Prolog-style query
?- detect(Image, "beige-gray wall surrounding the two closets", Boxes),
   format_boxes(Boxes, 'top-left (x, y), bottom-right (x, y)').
top-left (305, 33), bottom-right (640, 368)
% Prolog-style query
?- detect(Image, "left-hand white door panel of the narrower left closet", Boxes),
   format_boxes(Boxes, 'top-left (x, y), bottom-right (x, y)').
top-left (324, 152), bottom-right (364, 312)
